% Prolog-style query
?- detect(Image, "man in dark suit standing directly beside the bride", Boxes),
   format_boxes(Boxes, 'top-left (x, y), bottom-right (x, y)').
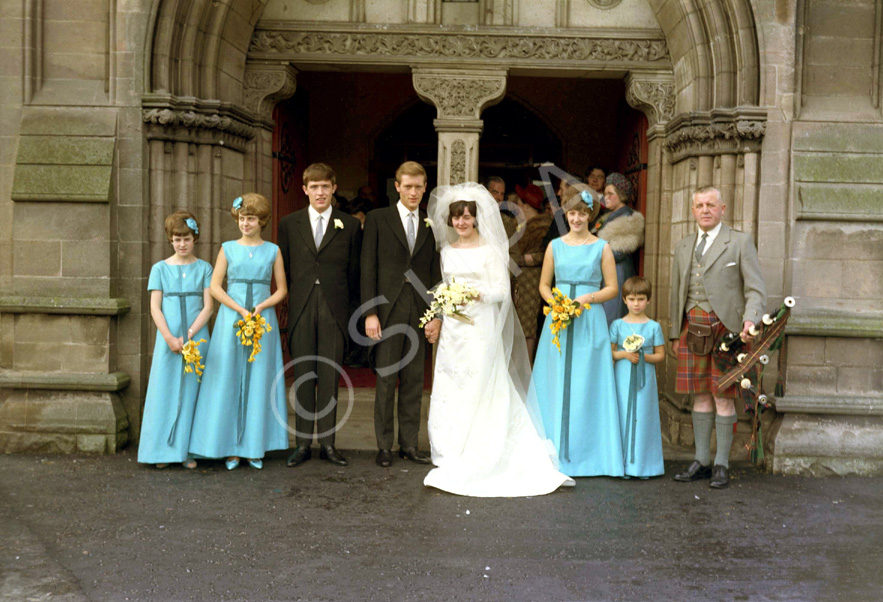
top-left (362, 161), bottom-right (441, 467)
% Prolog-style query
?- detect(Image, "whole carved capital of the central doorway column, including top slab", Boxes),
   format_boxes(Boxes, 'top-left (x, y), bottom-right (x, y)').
top-left (413, 69), bottom-right (506, 120)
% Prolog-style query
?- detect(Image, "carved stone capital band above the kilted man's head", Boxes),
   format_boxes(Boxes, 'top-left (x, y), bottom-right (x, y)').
top-left (665, 107), bottom-right (766, 163)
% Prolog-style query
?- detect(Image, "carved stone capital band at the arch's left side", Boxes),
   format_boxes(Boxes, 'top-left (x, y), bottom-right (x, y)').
top-left (141, 94), bottom-right (257, 151)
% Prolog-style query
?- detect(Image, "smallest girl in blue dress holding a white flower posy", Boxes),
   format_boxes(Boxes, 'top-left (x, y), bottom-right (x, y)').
top-left (610, 276), bottom-right (665, 478)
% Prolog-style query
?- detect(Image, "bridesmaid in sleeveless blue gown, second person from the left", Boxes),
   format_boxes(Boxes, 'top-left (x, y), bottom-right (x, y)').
top-left (190, 193), bottom-right (288, 470)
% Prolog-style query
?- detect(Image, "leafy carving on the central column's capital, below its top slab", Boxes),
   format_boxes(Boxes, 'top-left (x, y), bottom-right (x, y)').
top-left (414, 75), bottom-right (506, 119)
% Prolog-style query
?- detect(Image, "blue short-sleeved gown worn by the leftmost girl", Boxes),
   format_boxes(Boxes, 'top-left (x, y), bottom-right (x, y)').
top-left (138, 259), bottom-right (212, 464)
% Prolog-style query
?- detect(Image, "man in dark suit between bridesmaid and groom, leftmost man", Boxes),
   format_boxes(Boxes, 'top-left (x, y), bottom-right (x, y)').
top-left (279, 163), bottom-right (362, 466)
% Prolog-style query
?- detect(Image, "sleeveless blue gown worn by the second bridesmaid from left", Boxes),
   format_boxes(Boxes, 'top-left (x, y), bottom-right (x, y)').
top-left (190, 240), bottom-right (288, 459)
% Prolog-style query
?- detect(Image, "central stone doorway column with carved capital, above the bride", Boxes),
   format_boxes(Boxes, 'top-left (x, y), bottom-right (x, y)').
top-left (413, 68), bottom-right (506, 186)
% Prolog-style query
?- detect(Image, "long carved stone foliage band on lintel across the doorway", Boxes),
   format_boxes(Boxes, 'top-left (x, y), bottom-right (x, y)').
top-left (249, 30), bottom-right (671, 63)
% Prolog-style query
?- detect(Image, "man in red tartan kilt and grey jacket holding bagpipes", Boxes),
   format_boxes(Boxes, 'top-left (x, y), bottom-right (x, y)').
top-left (668, 186), bottom-right (766, 489)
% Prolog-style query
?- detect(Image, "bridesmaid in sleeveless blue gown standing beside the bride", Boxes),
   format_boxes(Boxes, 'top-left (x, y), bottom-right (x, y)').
top-left (531, 185), bottom-right (623, 477)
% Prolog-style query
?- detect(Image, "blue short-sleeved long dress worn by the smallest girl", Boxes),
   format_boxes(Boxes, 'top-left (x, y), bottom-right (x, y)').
top-left (610, 319), bottom-right (665, 477)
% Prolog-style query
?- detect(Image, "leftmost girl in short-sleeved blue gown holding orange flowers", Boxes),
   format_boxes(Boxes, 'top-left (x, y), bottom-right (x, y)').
top-left (138, 211), bottom-right (213, 469)
